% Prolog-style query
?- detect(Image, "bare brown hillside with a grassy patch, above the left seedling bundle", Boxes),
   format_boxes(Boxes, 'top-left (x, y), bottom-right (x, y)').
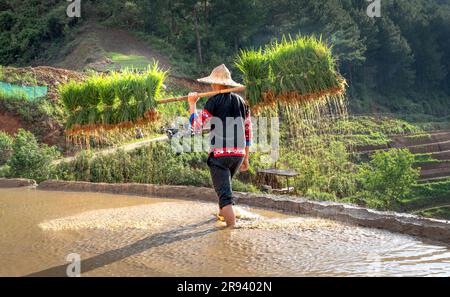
top-left (48, 21), bottom-right (209, 92)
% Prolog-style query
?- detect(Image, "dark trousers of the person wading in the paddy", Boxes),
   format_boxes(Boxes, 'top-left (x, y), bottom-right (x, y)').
top-left (207, 156), bottom-right (244, 209)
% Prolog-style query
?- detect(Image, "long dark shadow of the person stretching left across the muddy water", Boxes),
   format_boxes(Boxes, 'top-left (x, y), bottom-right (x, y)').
top-left (25, 219), bottom-right (223, 277)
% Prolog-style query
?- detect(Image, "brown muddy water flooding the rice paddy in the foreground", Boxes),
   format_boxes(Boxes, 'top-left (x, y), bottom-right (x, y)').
top-left (0, 189), bottom-right (450, 276)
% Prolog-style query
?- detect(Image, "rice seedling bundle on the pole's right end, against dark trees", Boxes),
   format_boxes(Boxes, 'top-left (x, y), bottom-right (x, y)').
top-left (236, 36), bottom-right (346, 112)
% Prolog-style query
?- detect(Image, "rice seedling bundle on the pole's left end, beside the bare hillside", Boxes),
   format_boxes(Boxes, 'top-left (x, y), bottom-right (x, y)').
top-left (61, 64), bottom-right (167, 141)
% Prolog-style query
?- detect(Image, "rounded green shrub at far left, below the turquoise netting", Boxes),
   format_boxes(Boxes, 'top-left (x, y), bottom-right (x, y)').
top-left (8, 129), bottom-right (60, 182)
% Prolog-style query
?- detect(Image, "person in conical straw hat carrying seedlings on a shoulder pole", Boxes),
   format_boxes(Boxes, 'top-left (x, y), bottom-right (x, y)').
top-left (188, 64), bottom-right (252, 227)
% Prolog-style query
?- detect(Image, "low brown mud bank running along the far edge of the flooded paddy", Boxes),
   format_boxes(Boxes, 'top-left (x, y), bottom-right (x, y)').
top-left (0, 179), bottom-right (450, 244)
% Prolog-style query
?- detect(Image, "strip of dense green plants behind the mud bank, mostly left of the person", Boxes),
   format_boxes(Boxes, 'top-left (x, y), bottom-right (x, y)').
top-left (56, 143), bottom-right (255, 191)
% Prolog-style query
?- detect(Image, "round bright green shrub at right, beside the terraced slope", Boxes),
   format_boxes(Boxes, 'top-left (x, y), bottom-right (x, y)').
top-left (358, 149), bottom-right (419, 209)
